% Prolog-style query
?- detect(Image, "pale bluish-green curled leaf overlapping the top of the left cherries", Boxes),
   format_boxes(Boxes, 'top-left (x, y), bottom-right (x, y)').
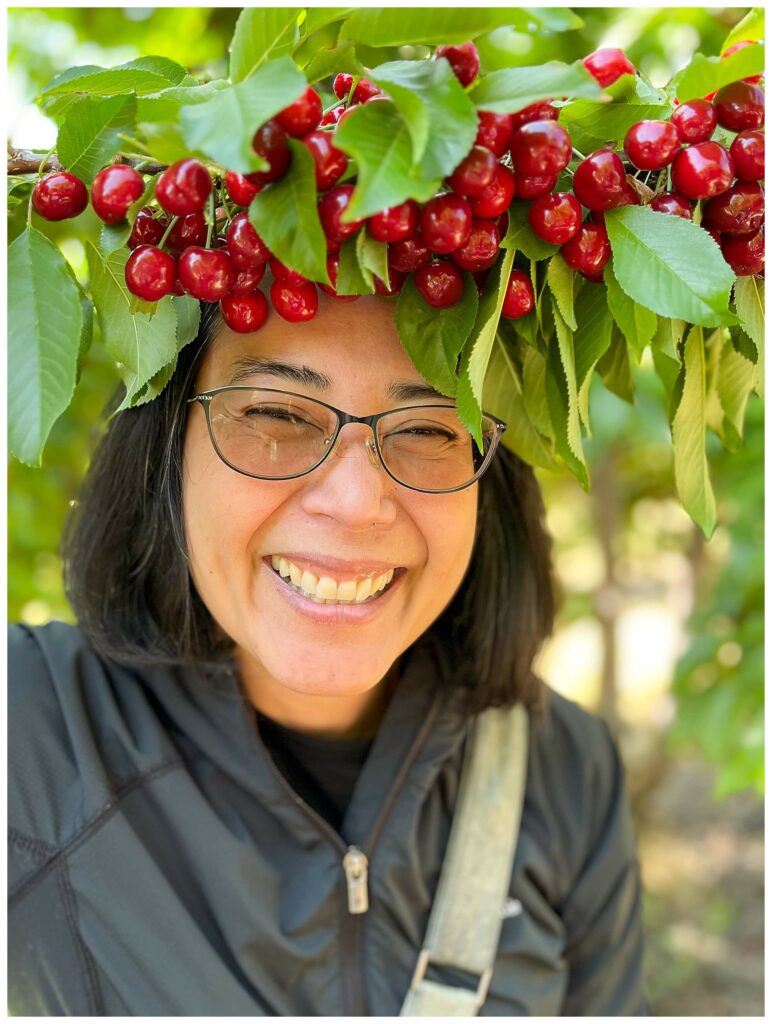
top-left (180, 57), bottom-right (307, 175)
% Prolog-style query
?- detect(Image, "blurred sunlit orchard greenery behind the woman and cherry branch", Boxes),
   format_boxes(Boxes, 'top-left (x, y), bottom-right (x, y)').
top-left (7, 7), bottom-right (764, 1016)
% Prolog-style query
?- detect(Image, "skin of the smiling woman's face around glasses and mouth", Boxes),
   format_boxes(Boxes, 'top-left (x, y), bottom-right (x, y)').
top-left (183, 296), bottom-right (477, 696)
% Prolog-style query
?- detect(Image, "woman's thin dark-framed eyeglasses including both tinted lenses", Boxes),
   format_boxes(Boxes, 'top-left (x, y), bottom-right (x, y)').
top-left (187, 386), bottom-right (507, 494)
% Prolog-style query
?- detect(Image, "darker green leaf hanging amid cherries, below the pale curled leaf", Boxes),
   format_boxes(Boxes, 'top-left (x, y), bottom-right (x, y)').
top-left (249, 138), bottom-right (330, 285)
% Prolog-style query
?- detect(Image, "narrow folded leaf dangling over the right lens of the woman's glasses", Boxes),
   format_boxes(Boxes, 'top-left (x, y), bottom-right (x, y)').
top-left (456, 250), bottom-right (515, 452)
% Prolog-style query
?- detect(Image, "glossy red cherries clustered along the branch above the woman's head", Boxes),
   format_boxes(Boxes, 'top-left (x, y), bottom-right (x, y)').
top-left (27, 42), bottom-right (764, 332)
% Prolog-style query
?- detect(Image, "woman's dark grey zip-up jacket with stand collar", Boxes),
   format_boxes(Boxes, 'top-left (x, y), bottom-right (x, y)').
top-left (8, 623), bottom-right (646, 1017)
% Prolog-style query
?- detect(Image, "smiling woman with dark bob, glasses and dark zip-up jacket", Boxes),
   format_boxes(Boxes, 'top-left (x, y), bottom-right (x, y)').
top-left (9, 296), bottom-right (645, 1016)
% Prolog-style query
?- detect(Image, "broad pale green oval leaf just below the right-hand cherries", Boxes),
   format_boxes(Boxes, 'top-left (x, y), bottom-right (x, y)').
top-left (606, 206), bottom-right (735, 326)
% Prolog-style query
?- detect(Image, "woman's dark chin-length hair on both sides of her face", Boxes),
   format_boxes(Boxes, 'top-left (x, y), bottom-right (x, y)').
top-left (62, 305), bottom-right (555, 714)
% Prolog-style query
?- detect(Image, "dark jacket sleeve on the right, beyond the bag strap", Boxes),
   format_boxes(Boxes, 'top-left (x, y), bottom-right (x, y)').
top-left (561, 722), bottom-right (648, 1017)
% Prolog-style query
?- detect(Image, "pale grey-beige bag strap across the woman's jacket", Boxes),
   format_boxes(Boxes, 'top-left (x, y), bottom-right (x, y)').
top-left (399, 705), bottom-right (528, 1017)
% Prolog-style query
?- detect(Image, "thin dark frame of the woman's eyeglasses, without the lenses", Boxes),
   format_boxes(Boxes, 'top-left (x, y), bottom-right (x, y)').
top-left (187, 384), bottom-right (507, 495)
